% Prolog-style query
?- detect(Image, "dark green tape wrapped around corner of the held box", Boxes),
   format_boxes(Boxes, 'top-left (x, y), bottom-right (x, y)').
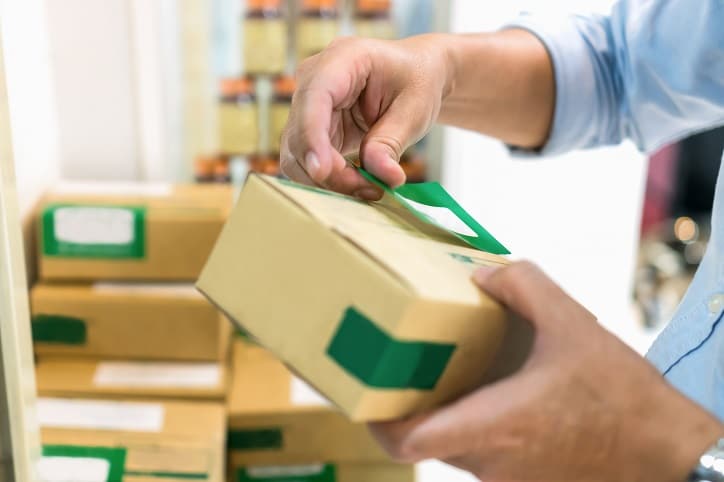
top-left (327, 307), bottom-right (456, 390)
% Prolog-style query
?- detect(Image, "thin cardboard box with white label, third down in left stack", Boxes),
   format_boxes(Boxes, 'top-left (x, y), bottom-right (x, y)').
top-left (35, 357), bottom-right (231, 401)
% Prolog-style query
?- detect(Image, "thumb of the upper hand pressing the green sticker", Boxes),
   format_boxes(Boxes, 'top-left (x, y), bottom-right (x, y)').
top-left (360, 94), bottom-right (430, 187)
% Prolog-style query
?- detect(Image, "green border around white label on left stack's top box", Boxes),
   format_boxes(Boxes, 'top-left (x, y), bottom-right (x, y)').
top-left (41, 204), bottom-right (146, 259)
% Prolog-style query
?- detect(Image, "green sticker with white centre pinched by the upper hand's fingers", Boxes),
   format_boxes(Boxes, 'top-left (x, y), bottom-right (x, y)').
top-left (359, 169), bottom-right (510, 254)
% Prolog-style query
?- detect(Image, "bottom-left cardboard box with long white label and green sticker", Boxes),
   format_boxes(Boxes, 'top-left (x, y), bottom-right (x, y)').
top-left (37, 398), bottom-right (225, 482)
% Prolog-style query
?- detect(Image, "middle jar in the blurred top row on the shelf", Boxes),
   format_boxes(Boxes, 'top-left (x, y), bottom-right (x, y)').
top-left (297, 0), bottom-right (339, 62)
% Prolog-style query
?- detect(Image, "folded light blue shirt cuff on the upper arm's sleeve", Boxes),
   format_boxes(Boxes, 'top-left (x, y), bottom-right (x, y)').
top-left (503, 15), bottom-right (598, 158)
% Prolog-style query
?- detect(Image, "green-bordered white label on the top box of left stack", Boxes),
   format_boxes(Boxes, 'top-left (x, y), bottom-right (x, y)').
top-left (41, 204), bottom-right (146, 259)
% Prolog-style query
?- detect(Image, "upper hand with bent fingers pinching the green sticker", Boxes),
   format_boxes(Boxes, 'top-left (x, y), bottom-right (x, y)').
top-left (280, 35), bottom-right (450, 200)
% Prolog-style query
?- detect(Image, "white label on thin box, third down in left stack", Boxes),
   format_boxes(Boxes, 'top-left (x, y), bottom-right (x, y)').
top-left (93, 362), bottom-right (221, 388)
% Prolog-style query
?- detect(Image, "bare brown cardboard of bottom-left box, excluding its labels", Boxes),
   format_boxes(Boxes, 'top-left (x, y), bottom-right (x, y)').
top-left (41, 402), bottom-right (225, 482)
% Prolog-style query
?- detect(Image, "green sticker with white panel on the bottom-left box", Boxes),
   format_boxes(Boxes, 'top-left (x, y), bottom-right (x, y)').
top-left (38, 445), bottom-right (126, 482)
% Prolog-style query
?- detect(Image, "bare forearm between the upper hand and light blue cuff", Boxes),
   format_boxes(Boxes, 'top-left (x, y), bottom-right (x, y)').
top-left (438, 30), bottom-right (555, 148)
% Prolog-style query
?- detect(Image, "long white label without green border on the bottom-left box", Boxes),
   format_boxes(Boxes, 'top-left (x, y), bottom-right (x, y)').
top-left (37, 398), bottom-right (164, 432)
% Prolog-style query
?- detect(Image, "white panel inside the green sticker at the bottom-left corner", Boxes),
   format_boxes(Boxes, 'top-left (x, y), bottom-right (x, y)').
top-left (36, 456), bottom-right (111, 482)
